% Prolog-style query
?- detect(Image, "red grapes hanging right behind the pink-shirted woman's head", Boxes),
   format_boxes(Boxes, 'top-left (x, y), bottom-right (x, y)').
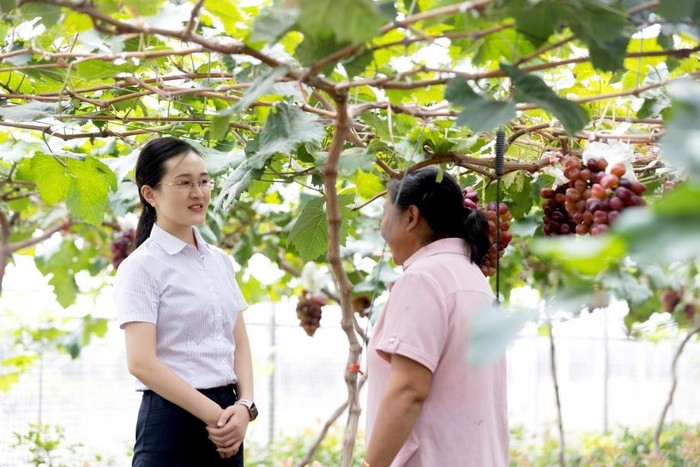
top-left (462, 186), bottom-right (513, 276)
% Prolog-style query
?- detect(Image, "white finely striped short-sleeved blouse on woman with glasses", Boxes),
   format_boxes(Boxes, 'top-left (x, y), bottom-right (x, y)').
top-left (114, 225), bottom-right (247, 390)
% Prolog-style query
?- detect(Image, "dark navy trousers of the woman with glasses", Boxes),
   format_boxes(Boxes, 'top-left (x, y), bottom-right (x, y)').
top-left (132, 384), bottom-right (243, 467)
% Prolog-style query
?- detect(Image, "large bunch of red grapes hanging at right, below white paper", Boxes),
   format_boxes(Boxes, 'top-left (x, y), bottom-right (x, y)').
top-left (540, 156), bottom-right (646, 236)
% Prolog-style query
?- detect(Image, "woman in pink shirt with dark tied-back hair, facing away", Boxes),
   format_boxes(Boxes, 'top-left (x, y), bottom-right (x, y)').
top-left (364, 167), bottom-right (508, 467)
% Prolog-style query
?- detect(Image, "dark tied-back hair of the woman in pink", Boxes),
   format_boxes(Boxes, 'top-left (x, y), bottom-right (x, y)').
top-left (388, 167), bottom-right (491, 265)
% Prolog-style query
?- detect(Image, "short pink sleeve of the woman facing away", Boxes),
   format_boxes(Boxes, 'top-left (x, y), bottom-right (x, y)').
top-left (377, 272), bottom-right (448, 372)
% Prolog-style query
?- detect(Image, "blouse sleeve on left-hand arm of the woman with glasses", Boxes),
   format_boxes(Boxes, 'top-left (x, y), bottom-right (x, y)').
top-left (114, 257), bottom-right (159, 329)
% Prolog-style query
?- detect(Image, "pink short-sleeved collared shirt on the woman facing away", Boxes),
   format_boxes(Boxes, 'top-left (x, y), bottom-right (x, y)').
top-left (367, 238), bottom-right (508, 467)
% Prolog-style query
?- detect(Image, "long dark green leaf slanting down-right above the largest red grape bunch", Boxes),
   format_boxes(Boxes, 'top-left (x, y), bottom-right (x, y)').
top-left (501, 64), bottom-right (589, 135)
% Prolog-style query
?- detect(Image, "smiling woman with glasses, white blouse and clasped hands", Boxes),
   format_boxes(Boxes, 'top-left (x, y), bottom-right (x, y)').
top-left (114, 137), bottom-right (257, 467)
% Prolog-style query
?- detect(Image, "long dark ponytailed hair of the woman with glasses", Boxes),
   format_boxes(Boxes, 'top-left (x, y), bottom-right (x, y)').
top-left (133, 136), bottom-right (201, 249)
